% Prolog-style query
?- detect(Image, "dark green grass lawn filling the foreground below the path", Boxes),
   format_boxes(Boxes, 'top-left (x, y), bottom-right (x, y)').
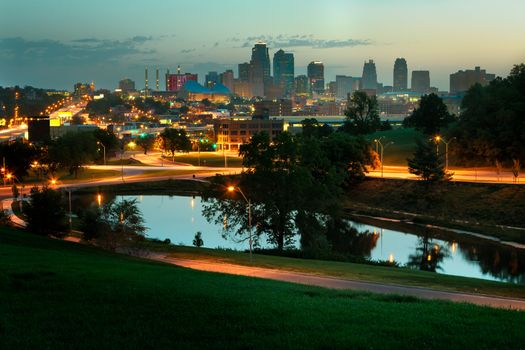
top-left (0, 228), bottom-right (525, 349)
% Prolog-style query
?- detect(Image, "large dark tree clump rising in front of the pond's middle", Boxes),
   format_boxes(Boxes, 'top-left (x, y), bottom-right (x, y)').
top-left (203, 132), bottom-right (370, 250)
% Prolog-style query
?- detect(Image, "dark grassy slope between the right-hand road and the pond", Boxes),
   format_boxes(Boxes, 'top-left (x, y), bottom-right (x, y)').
top-left (344, 178), bottom-right (525, 244)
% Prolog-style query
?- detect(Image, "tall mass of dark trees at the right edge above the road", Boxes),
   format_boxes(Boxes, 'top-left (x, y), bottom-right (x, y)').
top-left (453, 64), bottom-right (525, 167)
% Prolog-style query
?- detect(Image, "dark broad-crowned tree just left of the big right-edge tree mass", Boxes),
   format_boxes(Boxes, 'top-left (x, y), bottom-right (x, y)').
top-left (403, 94), bottom-right (455, 135)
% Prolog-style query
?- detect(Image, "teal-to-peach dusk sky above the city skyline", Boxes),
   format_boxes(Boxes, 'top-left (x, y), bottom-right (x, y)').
top-left (0, 0), bottom-right (525, 90)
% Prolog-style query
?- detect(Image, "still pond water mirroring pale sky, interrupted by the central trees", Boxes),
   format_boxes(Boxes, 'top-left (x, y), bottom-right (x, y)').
top-left (73, 194), bottom-right (525, 284)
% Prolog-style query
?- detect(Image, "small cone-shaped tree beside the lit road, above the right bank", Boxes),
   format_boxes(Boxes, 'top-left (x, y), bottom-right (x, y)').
top-left (408, 140), bottom-right (451, 183)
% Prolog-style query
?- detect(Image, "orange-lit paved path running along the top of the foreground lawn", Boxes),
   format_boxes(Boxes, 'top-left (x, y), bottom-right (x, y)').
top-left (150, 254), bottom-right (525, 310)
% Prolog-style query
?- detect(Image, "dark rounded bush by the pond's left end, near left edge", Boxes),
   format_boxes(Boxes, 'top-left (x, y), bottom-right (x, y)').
top-left (23, 187), bottom-right (67, 236)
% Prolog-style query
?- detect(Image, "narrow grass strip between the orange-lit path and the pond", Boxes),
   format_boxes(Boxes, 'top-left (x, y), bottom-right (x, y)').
top-left (149, 243), bottom-right (525, 299)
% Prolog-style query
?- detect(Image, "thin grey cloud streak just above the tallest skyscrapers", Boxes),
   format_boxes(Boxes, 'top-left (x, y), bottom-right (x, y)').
top-left (237, 34), bottom-right (373, 49)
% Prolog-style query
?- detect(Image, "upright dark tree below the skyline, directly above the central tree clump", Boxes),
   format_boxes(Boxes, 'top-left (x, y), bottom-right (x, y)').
top-left (342, 91), bottom-right (381, 135)
